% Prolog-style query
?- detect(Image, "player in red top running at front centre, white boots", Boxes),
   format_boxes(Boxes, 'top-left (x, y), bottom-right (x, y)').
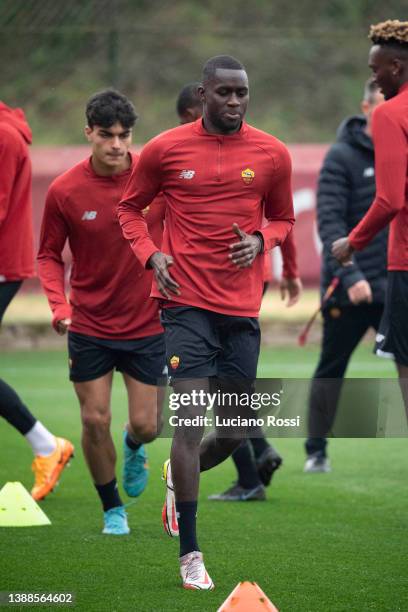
top-left (119, 56), bottom-right (294, 590)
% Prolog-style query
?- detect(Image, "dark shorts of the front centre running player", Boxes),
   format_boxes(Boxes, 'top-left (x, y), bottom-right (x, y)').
top-left (161, 306), bottom-right (261, 379)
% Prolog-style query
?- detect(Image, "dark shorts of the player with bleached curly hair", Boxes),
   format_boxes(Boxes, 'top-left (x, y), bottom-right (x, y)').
top-left (374, 270), bottom-right (408, 366)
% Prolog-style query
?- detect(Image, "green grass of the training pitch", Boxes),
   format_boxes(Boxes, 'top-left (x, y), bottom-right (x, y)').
top-left (0, 346), bottom-right (408, 612)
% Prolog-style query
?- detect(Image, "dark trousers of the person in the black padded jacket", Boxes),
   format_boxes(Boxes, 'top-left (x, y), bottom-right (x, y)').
top-left (305, 304), bottom-right (384, 457)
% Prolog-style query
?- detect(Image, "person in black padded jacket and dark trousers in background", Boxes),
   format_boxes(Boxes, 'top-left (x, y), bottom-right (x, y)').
top-left (304, 79), bottom-right (388, 472)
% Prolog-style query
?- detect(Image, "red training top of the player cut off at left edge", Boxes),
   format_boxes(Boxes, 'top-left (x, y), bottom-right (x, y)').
top-left (0, 102), bottom-right (34, 283)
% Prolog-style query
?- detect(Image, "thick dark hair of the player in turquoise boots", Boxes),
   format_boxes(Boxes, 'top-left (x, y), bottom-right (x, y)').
top-left (85, 89), bottom-right (137, 128)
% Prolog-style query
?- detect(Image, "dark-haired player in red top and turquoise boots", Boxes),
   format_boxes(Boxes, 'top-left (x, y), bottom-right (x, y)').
top-left (38, 90), bottom-right (165, 535)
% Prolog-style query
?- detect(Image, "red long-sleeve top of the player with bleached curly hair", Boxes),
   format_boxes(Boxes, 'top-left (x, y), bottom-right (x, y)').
top-left (349, 83), bottom-right (408, 270)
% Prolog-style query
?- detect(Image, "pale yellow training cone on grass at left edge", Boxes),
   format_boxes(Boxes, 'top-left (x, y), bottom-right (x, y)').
top-left (0, 482), bottom-right (51, 527)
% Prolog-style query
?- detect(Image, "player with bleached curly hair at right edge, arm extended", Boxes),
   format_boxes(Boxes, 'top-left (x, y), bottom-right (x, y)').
top-left (333, 20), bottom-right (408, 418)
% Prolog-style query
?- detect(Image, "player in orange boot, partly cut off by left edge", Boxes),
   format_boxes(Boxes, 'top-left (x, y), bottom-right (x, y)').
top-left (0, 102), bottom-right (74, 500)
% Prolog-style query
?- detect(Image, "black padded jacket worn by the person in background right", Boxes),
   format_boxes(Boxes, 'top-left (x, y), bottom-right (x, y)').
top-left (317, 116), bottom-right (388, 305)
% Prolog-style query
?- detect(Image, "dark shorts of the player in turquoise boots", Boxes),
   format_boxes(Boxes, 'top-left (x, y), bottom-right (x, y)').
top-left (68, 332), bottom-right (167, 385)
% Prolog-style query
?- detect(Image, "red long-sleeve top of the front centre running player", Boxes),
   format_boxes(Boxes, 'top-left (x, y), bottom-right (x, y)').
top-left (118, 119), bottom-right (294, 317)
